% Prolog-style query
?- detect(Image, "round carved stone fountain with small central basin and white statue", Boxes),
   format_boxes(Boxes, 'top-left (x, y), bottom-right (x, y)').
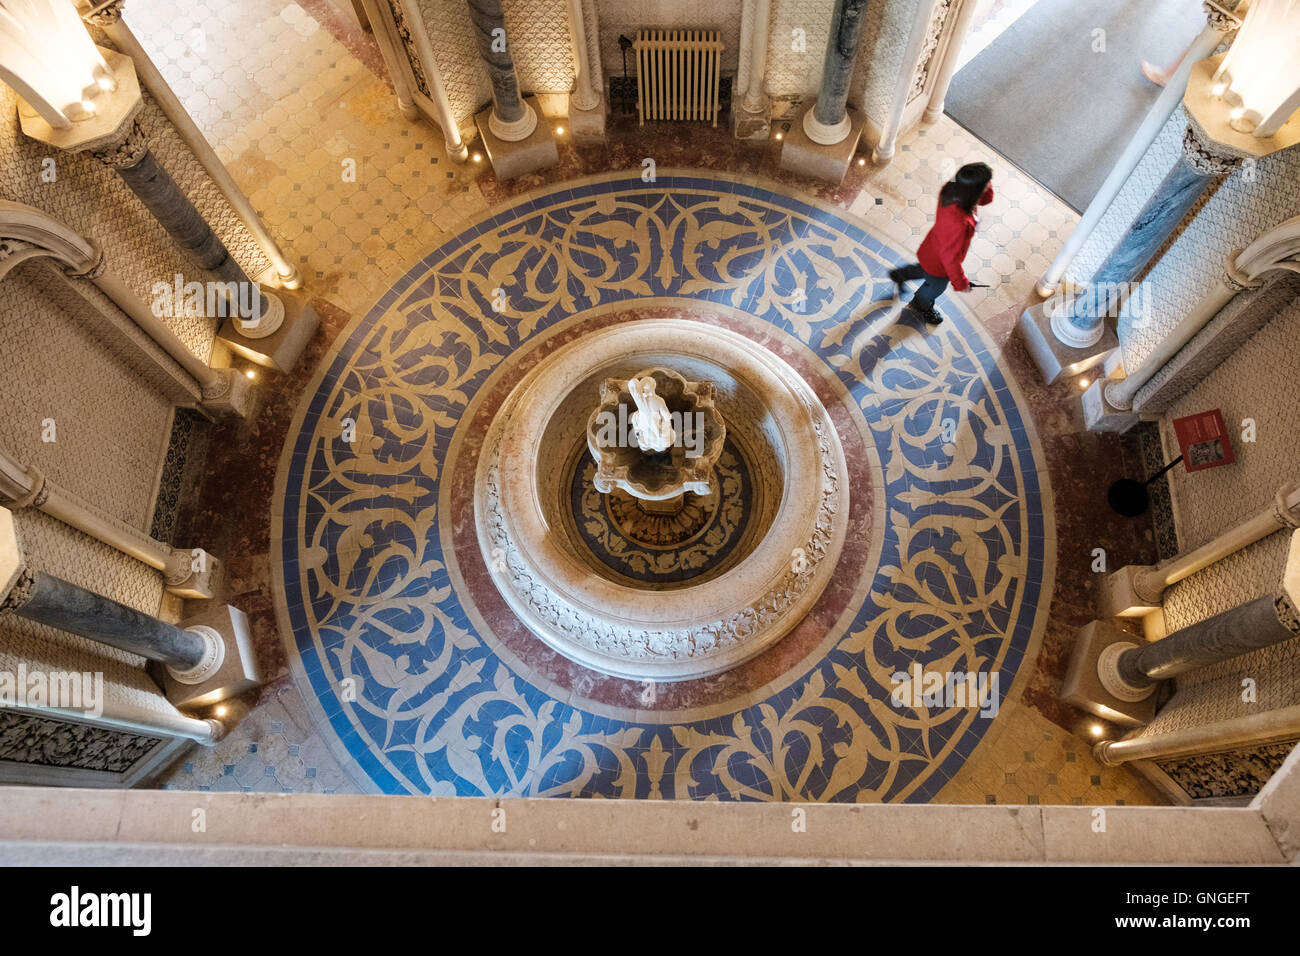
top-left (475, 319), bottom-right (849, 682)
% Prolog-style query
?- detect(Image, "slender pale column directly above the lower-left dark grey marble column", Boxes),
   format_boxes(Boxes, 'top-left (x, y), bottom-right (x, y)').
top-left (0, 449), bottom-right (216, 598)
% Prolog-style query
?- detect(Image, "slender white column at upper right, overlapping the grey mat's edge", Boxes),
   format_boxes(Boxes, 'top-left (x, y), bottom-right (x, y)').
top-left (1036, 12), bottom-right (1235, 298)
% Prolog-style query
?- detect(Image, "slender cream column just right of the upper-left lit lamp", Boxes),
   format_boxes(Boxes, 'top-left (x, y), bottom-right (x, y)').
top-left (86, 0), bottom-right (303, 289)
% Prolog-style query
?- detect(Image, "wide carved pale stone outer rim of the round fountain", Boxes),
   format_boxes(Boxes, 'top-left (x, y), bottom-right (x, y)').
top-left (475, 319), bottom-right (849, 682)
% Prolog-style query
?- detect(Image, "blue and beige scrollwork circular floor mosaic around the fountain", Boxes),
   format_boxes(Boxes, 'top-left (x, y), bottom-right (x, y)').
top-left (273, 174), bottom-right (1054, 801)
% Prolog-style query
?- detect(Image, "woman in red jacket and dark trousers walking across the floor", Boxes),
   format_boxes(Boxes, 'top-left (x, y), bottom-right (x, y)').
top-left (889, 163), bottom-right (993, 325)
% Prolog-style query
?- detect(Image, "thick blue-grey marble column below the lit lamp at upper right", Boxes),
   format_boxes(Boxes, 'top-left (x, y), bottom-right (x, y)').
top-left (1052, 126), bottom-right (1242, 349)
